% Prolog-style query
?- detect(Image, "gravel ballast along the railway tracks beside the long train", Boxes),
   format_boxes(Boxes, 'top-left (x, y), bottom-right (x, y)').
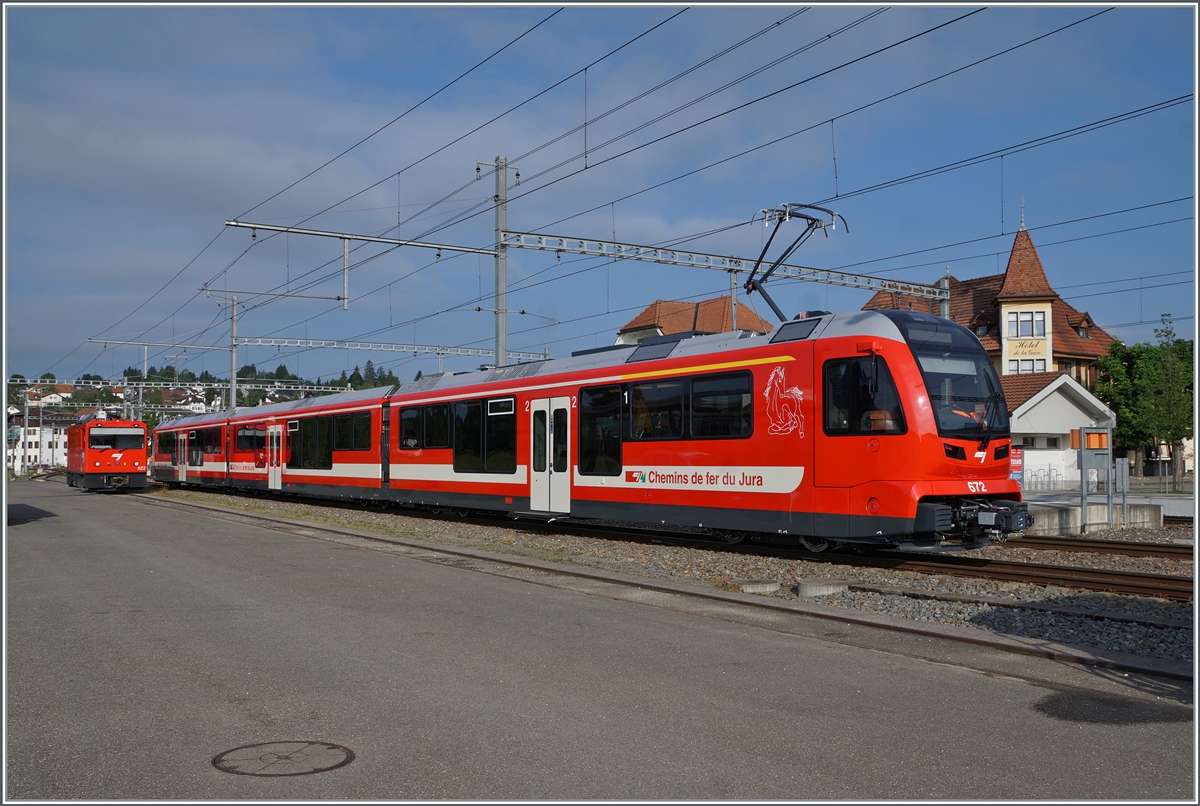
top-left (147, 491), bottom-right (1194, 662)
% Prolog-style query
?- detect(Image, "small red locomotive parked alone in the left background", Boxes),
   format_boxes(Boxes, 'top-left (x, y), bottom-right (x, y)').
top-left (67, 411), bottom-right (149, 489)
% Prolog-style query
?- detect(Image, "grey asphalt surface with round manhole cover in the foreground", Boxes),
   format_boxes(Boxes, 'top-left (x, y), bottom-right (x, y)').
top-left (6, 482), bottom-right (1195, 800)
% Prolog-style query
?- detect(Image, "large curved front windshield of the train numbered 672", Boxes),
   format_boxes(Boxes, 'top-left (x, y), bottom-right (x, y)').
top-left (881, 312), bottom-right (1010, 446)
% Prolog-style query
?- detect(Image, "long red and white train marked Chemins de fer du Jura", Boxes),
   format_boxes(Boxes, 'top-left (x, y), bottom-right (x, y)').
top-left (151, 311), bottom-right (1032, 551)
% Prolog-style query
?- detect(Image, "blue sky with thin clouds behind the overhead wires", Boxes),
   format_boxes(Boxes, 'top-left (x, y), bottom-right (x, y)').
top-left (5, 5), bottom-right (1196, 380)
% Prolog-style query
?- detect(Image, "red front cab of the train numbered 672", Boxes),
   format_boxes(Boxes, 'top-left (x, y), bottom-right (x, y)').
top-left (814, 311), bottom-right (1032, 551)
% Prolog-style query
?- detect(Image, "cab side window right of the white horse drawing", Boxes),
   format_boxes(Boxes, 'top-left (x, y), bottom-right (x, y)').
top-left (824, 355), bottom-right (906, 437)
